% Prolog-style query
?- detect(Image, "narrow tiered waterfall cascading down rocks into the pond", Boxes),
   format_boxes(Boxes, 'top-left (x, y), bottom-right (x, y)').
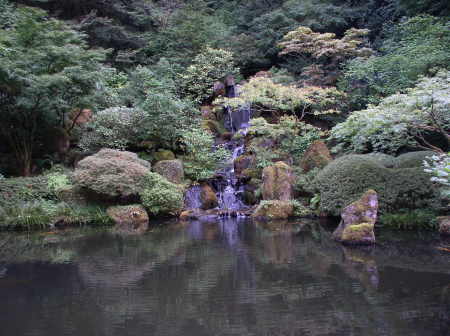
top-left (217, 85), bottom-right (251, 212)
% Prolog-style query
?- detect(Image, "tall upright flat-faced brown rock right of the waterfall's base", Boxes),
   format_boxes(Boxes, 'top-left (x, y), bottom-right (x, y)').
top-left (262, 161), bottom-right (294, 201)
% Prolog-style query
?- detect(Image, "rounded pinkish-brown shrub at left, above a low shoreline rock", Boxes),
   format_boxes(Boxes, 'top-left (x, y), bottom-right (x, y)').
top-left (73, 149), bottom-right (150, 199)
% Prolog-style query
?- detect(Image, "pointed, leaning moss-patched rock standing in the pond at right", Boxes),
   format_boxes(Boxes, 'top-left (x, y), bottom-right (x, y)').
top-left (333, 190), bottom-right (378, 245)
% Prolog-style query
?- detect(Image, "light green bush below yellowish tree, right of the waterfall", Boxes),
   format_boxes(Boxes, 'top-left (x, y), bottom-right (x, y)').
top-left (248, 116), bottom-right (324, 168)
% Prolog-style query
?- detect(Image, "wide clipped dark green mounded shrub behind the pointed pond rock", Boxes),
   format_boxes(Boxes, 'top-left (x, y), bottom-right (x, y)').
top-left (314, 155), bottom-right (439, 215)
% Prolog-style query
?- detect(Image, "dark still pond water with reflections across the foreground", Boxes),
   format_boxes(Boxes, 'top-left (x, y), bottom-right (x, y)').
top-left (0, 220), bottom-right (450, 336)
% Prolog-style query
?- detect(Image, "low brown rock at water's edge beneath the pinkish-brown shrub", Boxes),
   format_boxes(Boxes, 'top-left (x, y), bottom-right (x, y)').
top-left (106, 205), bottom-right (148, 234)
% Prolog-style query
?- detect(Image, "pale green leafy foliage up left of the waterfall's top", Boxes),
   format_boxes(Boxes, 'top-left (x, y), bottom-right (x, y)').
top-left (181, 47), bottom-right (239, 103)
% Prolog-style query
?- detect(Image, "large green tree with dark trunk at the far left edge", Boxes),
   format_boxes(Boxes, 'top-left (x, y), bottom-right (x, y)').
top-left (0, 7), bottom-right (106, 176)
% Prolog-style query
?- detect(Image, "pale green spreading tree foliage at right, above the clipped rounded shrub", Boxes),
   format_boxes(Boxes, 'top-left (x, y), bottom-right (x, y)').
top-left (332, 71), bottom-right (450, 153)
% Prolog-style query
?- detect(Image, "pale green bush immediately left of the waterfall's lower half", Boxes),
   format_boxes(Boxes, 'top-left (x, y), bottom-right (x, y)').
top-left (182, 128), bottom-right (230, 181)
